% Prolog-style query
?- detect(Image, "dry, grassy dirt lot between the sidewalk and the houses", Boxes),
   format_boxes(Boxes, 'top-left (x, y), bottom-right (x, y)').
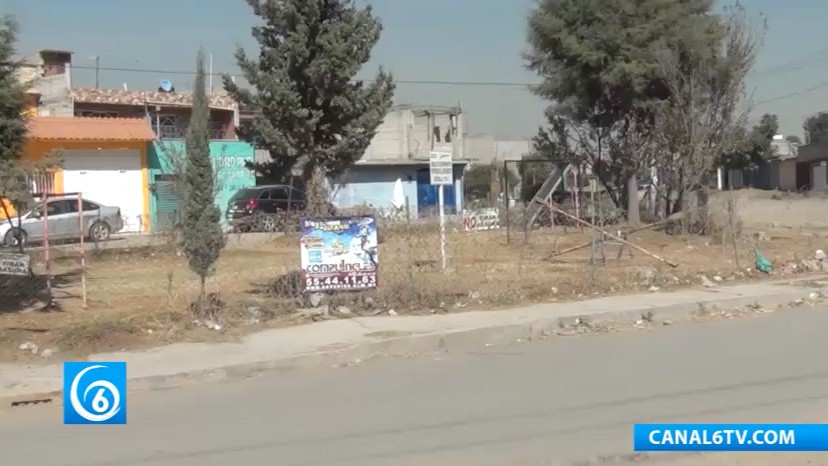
top-left (0, 195), bottom-right (828, 363)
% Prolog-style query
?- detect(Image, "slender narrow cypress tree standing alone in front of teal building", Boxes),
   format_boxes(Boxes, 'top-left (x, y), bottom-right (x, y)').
top-left (181, 50), bottom-right (227, 314)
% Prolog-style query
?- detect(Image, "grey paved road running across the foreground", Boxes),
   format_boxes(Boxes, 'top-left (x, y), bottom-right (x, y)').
top-left (0, 309), bottom-right (828, 466)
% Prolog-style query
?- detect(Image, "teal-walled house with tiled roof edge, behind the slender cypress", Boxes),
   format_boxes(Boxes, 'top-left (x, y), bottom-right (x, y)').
top-left (72, 89), bottom-right (256, 231)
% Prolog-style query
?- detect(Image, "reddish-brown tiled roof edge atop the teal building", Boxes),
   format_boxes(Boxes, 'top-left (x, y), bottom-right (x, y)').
top-left (72, 88), bottom-right (236, 110)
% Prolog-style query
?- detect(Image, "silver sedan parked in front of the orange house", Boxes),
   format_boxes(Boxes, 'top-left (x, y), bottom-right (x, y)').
top-left (0, 196), bottom-right (124, 246)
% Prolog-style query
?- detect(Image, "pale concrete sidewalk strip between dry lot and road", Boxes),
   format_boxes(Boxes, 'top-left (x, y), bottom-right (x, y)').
top-left (0, 282), bottom-right (828, 406)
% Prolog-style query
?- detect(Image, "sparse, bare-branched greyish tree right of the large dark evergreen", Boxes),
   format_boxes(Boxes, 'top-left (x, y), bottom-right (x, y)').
top-left (653, 4), bottom-right (765, 222)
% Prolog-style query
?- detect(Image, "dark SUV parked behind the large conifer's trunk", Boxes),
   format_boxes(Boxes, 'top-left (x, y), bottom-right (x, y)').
top-left (225, 185), bottom-right (334, 232)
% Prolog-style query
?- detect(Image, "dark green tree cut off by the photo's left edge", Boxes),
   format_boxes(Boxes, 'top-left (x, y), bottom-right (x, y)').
top-left (0, 16), bottom-right (59, 253)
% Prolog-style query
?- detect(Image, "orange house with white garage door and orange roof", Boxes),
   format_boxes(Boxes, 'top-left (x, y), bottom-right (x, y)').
top-left (4, 50), bottom-right (155, 232)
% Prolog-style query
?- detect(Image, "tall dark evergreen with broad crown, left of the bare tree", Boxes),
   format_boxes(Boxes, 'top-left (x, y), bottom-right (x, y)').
top-left (525, 0), bottom-right (714, 223)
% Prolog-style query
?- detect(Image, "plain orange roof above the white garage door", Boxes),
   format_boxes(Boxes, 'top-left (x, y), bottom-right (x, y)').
top-left (29, 117), bottom-right (156, 141)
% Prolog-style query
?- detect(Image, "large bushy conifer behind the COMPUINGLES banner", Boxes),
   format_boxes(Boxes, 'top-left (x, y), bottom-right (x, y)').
top-left (223, 0), bottom-right (394, 213)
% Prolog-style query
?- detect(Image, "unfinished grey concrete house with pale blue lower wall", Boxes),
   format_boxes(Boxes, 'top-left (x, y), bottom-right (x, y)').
top-left (331, 105), bottom-right (470, 215)
